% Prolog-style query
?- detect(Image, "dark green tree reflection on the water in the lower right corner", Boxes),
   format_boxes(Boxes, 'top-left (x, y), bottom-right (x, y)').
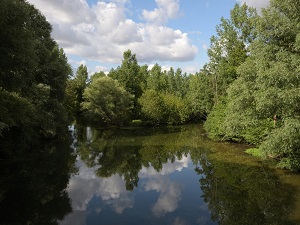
top-left (196, 154), bottom-right (295, 225)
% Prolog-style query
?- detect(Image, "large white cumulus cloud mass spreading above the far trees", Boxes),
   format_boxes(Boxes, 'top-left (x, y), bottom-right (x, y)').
top-left (29, 0), bottom-right (198, 63)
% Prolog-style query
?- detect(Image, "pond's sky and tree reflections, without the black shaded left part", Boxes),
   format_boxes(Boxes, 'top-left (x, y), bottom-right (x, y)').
top-left (61, 126), bottom-right (296, 225)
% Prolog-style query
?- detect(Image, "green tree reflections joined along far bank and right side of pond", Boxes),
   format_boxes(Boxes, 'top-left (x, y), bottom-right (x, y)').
top-left (70, 125), bottom-right (300, 225)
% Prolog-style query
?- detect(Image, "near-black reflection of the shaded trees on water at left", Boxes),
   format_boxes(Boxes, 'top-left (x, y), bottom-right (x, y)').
top-left (0, 134), bottom-right (75, 225)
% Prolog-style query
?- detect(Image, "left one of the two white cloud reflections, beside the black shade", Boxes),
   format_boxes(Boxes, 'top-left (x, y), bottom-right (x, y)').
top-left (60, 160), bottom-right (134, 225)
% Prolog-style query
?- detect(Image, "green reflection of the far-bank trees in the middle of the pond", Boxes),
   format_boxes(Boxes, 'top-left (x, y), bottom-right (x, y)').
top-left (77, 125), bottom-right (188, 190)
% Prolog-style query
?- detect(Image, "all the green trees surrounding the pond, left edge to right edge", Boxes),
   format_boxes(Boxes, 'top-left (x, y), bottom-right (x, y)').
top-left (0, 0), bottom-right (300, 171)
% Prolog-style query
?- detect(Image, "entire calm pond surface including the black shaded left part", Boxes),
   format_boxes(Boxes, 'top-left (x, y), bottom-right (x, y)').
top-left (0, 125), bottom-right (300, 225)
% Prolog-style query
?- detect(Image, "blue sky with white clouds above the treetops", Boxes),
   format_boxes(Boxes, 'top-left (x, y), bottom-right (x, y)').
top-left (28, 0), bottom-right (269, 74)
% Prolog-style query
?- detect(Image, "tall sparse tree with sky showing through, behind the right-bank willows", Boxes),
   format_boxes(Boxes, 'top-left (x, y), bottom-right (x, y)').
top-left (207, 4), bottom-right (257, 104)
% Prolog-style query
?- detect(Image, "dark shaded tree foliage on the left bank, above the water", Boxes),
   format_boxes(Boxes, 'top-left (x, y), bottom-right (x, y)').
top-left (0, 0), bottom-right (71, 141)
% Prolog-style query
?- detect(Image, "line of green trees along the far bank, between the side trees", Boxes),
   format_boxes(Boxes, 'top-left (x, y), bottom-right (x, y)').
top-left (67, 50), bottom-right (205, 126)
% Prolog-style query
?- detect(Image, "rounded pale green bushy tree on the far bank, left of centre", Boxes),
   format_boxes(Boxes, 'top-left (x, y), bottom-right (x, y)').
top-left (81, 77), bottom-right (133, 126)
